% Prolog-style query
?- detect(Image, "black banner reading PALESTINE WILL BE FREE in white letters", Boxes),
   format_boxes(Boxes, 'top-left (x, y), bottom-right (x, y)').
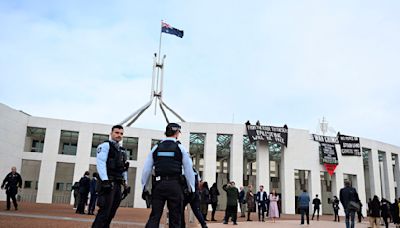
top-left (246, 124), bottom-right (288, 146)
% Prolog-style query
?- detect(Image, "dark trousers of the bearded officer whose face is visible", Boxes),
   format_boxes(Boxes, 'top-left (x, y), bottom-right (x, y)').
top-left (92, 182), bottom-right (121, 228)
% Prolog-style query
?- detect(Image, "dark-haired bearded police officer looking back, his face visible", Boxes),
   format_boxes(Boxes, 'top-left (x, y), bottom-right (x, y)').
top-left (92, 125), bottom-right (129, 228)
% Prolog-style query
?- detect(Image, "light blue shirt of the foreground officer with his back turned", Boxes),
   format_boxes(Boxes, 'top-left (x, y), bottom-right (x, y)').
top-left (142, 137), bottom-right (195, 192)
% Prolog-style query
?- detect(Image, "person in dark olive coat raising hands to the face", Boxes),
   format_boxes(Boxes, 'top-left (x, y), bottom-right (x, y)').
top-left (222, 181), bottom-right (239, 225)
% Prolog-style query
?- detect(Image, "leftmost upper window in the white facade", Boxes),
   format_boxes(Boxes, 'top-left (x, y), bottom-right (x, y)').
top-left (24, 127), bottom-right (46, 153)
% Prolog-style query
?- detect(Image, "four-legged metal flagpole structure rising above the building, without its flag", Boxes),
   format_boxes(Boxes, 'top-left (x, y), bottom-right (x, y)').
top-left (120, 21), bottom-right (186, 127)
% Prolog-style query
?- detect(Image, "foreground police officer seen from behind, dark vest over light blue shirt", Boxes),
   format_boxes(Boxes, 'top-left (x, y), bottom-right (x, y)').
top-left (142, 123), bottom-right (195, 228)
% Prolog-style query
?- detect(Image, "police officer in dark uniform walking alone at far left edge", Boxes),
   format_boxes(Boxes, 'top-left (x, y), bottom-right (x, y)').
top-left (1, 167), bottom-right (22, 210)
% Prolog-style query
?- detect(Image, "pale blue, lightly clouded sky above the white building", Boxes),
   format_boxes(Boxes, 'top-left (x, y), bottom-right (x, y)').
top-left (0, 0), bottom-right (400, 145)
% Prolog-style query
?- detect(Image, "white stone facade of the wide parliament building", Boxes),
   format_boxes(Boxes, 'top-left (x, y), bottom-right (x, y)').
top-left (0, 104), bottom-right (400, 215)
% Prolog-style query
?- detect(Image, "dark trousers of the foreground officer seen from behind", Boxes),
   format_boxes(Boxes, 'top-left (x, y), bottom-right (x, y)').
top-left (146, 180), bottom-right (183, 228)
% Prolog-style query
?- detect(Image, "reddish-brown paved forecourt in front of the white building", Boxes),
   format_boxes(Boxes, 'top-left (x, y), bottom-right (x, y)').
top-left (0, 201), bottom-right (378, 228)
